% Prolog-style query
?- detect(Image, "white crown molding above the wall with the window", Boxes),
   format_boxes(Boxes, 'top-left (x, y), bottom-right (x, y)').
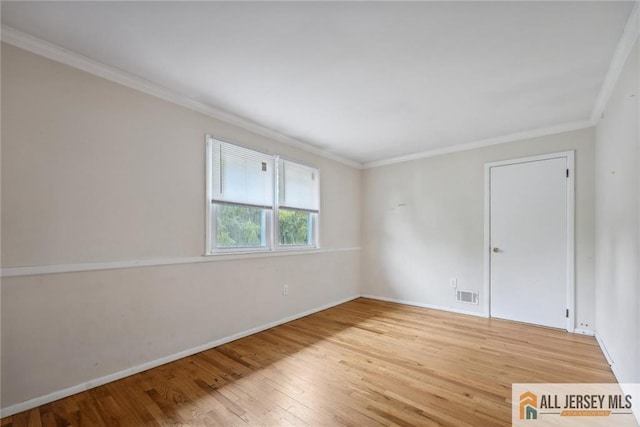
top-left (1, 25), bottom-right (362, 169)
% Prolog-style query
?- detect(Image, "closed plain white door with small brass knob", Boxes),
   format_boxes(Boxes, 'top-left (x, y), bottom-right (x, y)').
top-left (489, 157), bottom-right (572, 328)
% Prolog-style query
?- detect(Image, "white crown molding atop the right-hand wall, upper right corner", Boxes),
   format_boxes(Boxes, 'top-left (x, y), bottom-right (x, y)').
top-left (591, 0), bottom-right (640, 125)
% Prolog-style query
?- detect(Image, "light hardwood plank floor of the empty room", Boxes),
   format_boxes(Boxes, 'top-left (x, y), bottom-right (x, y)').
top-left (1, 298), bottom-right (615, 427)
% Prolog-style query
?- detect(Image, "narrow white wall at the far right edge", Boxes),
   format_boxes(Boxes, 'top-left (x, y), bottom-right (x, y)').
top-left (596, 36), bottom-right (640, 382)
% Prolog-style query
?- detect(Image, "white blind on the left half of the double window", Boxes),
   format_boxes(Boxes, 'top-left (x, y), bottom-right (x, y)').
top-left (207, 137), bottom-right (274, 209)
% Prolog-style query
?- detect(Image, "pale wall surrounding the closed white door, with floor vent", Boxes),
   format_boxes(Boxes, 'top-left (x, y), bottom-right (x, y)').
top-left (363, 128), bottom-right (595, 330)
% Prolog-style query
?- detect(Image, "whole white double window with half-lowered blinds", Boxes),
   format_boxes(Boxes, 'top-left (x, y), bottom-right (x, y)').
top-left (206, 135), bottom-right (320, 255)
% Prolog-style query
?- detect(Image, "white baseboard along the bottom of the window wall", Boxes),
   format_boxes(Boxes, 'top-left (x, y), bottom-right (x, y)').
top-left (0, 295), bottom-right (359, 418)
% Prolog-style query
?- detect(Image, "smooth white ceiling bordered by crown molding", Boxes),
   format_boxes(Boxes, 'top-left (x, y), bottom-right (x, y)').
top-left (2, 1), bottom-right (633, 164)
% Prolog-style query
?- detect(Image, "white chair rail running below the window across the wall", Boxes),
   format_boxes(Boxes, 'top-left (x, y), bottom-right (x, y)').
top-left (0, 246), bottom-right (360, 277)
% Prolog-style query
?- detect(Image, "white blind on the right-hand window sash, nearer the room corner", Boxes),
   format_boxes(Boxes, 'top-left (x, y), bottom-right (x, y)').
top-left (278, 159), bottom-right (320, 213)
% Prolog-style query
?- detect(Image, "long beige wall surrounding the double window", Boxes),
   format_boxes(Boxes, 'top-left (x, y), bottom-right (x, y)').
top-left (0, 45), bottom-right (361, 408)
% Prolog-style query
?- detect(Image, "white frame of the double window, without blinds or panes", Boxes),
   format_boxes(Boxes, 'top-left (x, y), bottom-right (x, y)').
top-left (204, 134), bottom-right (321, 256)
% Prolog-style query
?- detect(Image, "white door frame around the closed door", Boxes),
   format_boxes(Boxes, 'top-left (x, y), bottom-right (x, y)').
top-left (484, 150), bottom-right (576, 332)
